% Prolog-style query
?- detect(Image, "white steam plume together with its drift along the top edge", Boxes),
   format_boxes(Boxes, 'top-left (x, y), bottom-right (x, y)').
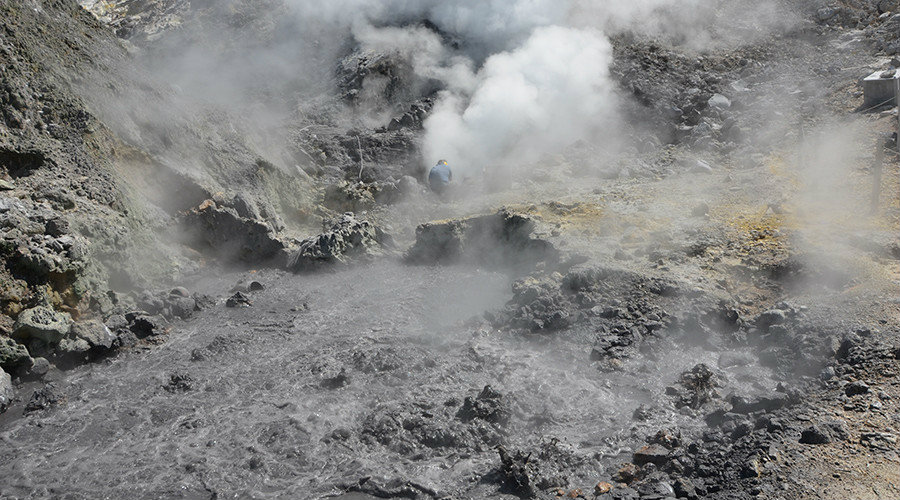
top-left (312, 0), bottom-right (792, 175)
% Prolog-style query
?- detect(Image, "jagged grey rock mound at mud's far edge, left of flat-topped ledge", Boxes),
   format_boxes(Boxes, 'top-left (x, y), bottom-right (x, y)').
top-left (288, 213), bottom-right (392, 272)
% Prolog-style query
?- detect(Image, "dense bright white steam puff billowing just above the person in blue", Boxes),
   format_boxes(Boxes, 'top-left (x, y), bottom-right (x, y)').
top-left (424, 26), bottom-right (614, 178)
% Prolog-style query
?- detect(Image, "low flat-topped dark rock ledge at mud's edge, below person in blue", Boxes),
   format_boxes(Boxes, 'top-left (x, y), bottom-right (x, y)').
top-left (405, 210), bottom-right (559, 268)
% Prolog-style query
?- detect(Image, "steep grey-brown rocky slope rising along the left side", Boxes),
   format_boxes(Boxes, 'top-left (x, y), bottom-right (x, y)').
top-left (0, 1), bottom-right (326, 372)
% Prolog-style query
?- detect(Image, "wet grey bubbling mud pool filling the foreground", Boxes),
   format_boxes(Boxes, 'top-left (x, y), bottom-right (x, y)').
top-left (0, 261), bottom-right (771, 498)
